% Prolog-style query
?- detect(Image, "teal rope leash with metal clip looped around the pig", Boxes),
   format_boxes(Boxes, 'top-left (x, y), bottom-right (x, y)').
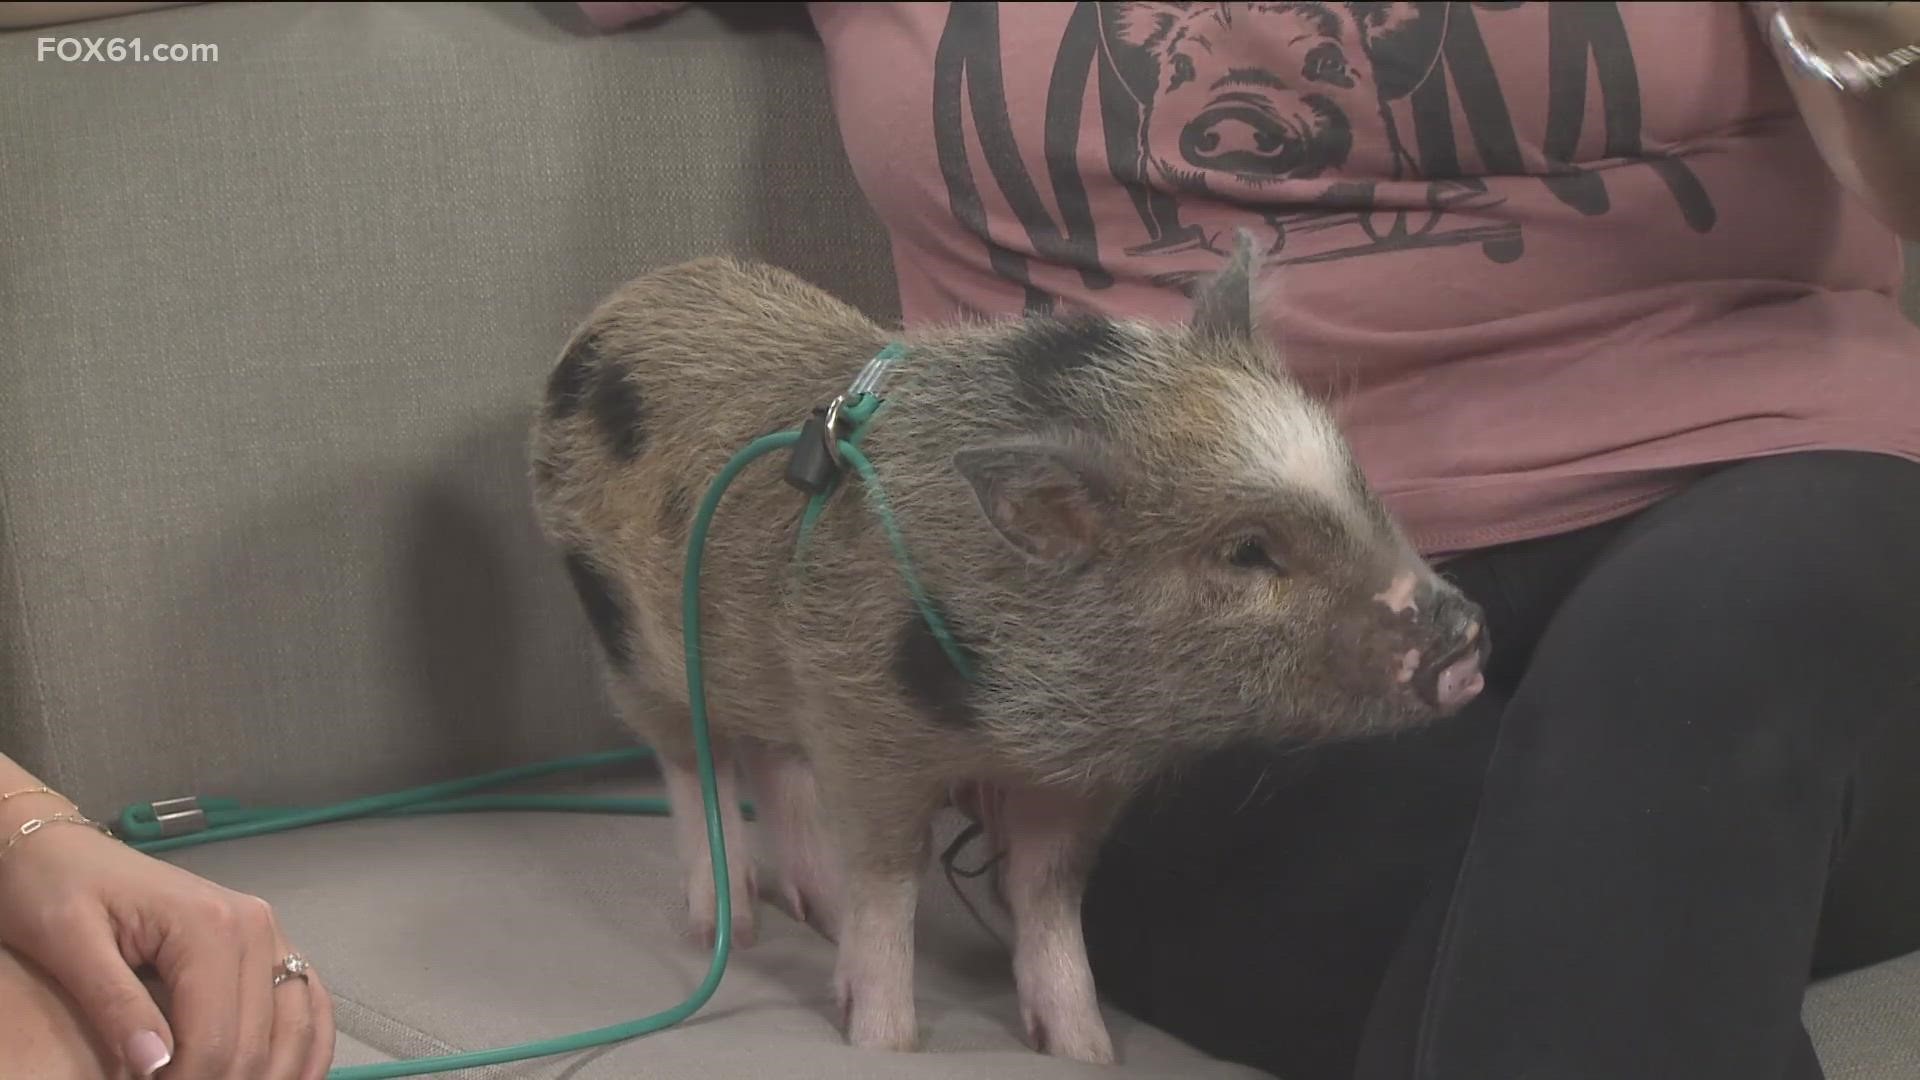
top-left (113, 346), bottom-right (973, 1080)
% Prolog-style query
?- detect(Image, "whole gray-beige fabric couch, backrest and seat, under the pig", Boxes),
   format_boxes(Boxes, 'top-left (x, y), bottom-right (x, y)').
top-left (0, 4), bottom-right (1920, 1080)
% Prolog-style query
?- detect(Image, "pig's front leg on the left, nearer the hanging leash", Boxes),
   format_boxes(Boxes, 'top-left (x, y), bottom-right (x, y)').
top-left (816, 761), bottom-right (937, 1051)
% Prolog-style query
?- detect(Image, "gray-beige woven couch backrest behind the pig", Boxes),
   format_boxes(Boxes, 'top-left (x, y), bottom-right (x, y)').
top-left (0, 4), bottom-right (893, 801)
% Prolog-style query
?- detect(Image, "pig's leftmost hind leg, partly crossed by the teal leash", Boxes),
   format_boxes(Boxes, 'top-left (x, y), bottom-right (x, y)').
top-left (612, 680), bottom-right (758, 949)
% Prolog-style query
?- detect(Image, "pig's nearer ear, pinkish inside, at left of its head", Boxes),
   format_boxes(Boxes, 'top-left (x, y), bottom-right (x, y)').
top-left (954, 442), bottom-right (1112, 571)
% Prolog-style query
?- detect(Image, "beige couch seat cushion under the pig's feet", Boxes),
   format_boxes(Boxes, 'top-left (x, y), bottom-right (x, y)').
top-left (177, 780), bottom-right (1260, 1080)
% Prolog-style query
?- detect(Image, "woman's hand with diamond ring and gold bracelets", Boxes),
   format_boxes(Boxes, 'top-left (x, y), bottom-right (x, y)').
top-left (0, 796), bottom-right (334, 1080)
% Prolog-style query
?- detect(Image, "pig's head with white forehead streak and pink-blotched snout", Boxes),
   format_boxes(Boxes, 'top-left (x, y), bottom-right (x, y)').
top-left (906, 233), bottom-right (1490, 774)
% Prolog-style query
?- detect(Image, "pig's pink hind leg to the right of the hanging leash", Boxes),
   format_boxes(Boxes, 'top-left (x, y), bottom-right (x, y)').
top-left (739, 740), bottom-right (843, 942)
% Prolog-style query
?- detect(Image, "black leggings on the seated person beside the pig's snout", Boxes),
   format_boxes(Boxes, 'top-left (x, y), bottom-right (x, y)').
top-left (1085, 454), bottom-right (1920, 1080)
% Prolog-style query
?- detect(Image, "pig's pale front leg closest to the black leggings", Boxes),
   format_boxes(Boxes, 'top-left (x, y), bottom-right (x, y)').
top-left (998, 788), bottom-right (1116, 1065)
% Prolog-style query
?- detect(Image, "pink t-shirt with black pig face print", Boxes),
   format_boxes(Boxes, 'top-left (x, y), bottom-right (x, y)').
top-left (582, 2), bottom-right (1920, 555)
